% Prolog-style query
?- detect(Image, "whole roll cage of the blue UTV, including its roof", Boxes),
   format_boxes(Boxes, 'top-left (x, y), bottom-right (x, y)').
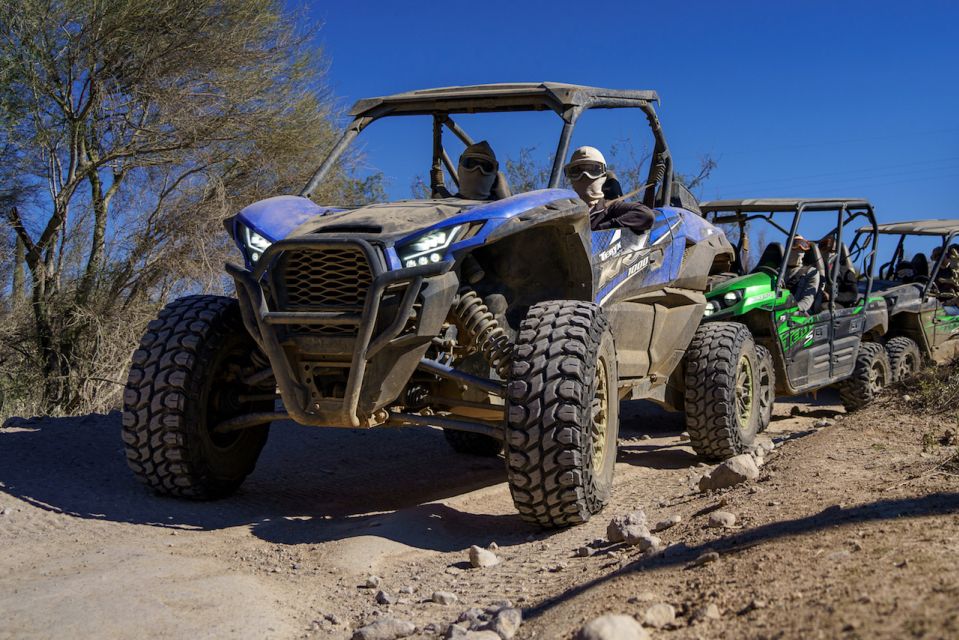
top-left (300, 82), bottom-right (673, 206)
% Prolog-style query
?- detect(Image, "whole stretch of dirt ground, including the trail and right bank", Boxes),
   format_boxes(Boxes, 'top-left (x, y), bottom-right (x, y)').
top-left (0, 390), bottom-right (959, 638)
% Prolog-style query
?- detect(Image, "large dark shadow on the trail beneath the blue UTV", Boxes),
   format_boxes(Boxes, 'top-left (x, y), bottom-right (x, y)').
top-left (0, 413), bottom-right (534, 550)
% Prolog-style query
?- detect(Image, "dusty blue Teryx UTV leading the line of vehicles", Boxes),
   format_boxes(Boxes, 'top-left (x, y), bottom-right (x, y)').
top-left (123, 83), bottom-right (736, 527)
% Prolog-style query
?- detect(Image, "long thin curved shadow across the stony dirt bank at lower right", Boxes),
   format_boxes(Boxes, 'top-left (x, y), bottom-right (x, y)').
top-left (523, 493), bottom-right (959, 620)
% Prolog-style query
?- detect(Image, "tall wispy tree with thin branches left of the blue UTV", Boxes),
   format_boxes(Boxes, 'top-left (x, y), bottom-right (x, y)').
top-left (0, 0), bottom-right (358, 411)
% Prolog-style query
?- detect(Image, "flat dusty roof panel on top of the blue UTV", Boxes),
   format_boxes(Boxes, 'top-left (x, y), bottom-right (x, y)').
top-left (350, 82), bottom-right (659, 117)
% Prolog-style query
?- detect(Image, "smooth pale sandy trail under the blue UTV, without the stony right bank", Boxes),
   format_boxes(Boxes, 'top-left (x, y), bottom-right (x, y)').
top-left (0, 398), bottom-right (928, 638)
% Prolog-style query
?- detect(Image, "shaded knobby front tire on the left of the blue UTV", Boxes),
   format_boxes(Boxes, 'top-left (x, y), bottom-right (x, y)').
top-left (123, 296), bottom-right (273, 499)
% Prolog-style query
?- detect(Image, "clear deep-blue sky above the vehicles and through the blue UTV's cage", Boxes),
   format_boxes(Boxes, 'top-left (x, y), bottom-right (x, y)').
top-left (308, 0), bottom-right (959, 249)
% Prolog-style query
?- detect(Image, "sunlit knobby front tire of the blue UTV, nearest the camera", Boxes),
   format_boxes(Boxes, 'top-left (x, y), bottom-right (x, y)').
top-left (506, 300), bottom-right (619, 527)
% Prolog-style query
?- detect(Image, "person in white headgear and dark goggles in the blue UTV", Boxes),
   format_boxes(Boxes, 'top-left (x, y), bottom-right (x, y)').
top-left (564, 147), bottom-right (656, 233)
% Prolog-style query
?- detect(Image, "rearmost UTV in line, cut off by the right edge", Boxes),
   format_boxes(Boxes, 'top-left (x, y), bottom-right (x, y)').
top-left (859, 220), bottom-right (959, 381)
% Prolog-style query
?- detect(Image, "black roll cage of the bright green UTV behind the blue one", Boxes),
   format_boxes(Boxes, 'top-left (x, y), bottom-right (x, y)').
top-left (700, 199), bottom-right (879, 313)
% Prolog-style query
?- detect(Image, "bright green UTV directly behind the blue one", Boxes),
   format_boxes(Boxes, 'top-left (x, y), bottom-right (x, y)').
top-left (686, 199), bottom-right (892, 422)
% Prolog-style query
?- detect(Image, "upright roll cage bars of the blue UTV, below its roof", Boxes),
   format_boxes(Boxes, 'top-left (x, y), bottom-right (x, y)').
top-left (299, 98), bottom-right (673, 206)
